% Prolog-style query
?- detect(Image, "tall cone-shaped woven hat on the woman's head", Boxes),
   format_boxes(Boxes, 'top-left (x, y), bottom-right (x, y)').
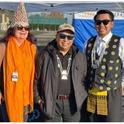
top-left (10, 2), bottom-right (29, 27)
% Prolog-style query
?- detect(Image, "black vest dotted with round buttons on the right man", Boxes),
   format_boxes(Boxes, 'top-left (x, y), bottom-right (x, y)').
top-left (86, 35), bottom-right (122, 91)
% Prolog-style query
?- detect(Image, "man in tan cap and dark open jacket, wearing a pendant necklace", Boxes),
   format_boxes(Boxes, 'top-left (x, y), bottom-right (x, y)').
top-left (35, 24), bottom-right (87, 122)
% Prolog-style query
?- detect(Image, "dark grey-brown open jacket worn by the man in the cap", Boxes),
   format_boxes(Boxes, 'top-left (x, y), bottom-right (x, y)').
top-left (35, 40), bottom-right (87, 117)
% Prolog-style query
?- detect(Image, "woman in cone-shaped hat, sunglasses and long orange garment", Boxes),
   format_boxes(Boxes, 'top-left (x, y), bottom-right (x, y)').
top-left (0, 3), bottom-right (36, 122)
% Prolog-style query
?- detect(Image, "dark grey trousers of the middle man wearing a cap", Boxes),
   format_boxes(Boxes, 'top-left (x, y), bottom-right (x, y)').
top-left (46, 96), bottom-right (80, 122)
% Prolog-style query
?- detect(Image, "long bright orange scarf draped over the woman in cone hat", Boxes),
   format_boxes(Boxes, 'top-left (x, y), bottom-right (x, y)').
top-left (4, 37), bottom-right (36, 122)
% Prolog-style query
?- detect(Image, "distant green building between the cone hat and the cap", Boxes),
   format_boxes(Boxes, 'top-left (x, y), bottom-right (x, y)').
top-left (29, 12), bottom-right (67, 31)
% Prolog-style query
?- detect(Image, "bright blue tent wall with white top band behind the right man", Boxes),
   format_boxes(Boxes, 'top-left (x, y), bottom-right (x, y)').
top-left (73, 11), bottom-right (124, 51)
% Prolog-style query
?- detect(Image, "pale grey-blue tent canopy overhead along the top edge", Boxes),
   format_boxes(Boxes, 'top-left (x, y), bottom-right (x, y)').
top-left (0, 0), bottom-right (124, 13)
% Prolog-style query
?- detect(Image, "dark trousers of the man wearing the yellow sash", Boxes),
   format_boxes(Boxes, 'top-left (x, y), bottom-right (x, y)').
top-left (88, 88), bottom-right (122, 122)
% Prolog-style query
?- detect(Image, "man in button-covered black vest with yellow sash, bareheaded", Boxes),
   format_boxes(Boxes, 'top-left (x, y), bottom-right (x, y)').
top-left (86, 10), bottom-right (124, 122)
